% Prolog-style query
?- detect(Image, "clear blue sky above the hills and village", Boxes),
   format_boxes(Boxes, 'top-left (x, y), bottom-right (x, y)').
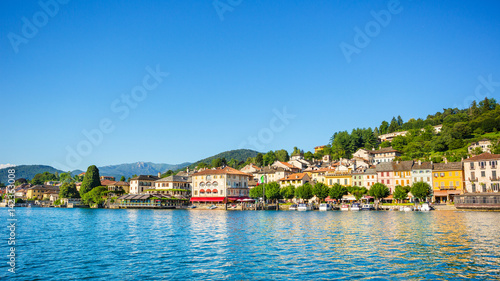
top-left (0, 0), bottom-right (500, 169)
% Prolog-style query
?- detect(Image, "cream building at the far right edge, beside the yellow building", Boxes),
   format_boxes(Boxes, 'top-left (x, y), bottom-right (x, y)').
top-left (464, 152), bottom-right (500, 193)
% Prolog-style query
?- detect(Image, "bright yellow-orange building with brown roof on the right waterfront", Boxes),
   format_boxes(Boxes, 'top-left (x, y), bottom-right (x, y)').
top-left (432, 160), bottom-right (464, 203)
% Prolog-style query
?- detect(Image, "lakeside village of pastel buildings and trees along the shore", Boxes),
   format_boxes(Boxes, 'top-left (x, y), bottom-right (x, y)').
top-left (2, 133), bottom-right (500, 210)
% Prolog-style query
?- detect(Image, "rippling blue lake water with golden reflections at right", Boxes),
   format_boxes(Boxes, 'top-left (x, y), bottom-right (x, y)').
top-left (0, 208), bottom-right (500, 280)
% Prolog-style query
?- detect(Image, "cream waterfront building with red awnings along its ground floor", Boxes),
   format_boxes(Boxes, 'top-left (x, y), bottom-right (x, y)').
top-left (191, 167), bottom-right (253, 203)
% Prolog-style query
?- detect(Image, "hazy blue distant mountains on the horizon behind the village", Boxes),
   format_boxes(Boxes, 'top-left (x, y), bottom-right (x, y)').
top-left (0, 149), bottom-right (258, 184)
